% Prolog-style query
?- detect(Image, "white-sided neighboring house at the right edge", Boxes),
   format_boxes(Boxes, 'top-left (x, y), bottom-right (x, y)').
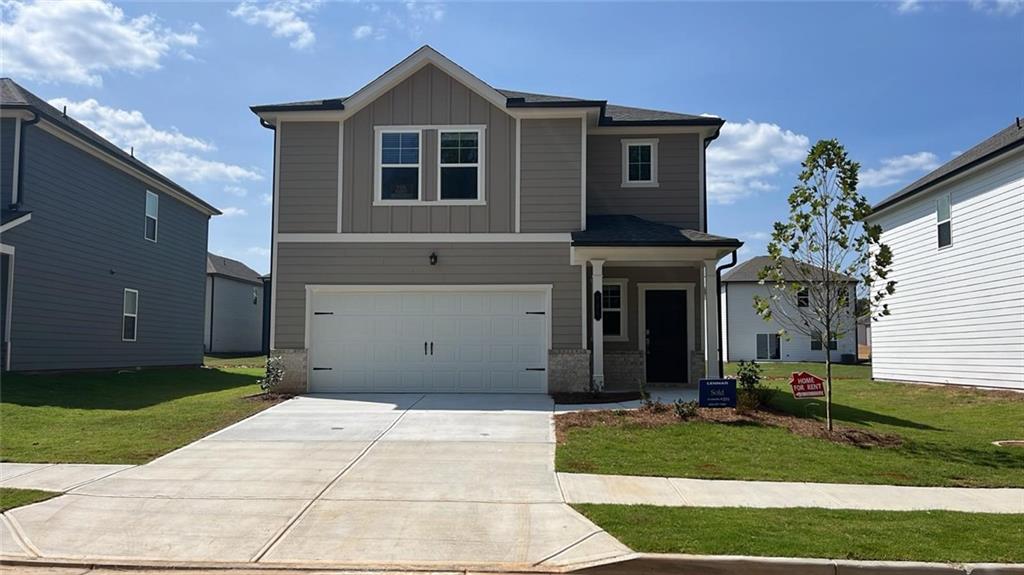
top-left (870, 119), bottom-right (1024, 390)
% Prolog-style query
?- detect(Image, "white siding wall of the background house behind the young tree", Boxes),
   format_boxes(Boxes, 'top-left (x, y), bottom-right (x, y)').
top-left (722, 281), bottom-right (857, 363)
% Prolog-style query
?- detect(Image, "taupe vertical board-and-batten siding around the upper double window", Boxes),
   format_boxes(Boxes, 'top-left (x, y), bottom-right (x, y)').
top-left (342, 65), bottom-right (515, 233)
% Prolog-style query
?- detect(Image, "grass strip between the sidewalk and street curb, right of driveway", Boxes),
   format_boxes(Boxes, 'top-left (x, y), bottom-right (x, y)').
top-left (573, 504), bottom-right (1024, 563)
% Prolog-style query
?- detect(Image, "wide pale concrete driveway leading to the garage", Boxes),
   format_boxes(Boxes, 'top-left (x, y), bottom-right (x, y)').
top-left (0, 394), bottom-right (630, 571)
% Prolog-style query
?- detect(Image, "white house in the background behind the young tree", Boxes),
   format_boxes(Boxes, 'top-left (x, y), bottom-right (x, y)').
top-left (722, 256), bottom-right (857, 363)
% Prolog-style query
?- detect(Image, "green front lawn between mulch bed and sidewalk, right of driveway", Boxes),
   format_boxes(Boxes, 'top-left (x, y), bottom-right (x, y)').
top-left (556, 363), bottom-right (1024, 487)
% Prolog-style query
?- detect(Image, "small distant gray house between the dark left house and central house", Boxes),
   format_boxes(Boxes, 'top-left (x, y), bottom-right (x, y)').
top-left (203, 254), bottom-right (263, 354)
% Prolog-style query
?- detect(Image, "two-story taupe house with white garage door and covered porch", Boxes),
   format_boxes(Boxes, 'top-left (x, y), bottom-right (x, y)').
top-left (252, 46), bottom-right (740, 393)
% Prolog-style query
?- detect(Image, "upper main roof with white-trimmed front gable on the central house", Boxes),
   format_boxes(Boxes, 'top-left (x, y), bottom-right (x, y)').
top-left (250, 46), bottom-right (725, 127)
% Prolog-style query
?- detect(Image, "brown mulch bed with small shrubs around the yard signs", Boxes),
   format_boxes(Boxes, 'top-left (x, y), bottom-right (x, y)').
top-left (555, 407), bottom-right (903, 448)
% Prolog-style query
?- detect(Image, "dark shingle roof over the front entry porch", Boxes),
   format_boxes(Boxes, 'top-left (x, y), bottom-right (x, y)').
top-left (572, 216), bottom-right (742, 243)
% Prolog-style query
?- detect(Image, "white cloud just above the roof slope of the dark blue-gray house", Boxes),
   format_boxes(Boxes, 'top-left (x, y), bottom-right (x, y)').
top-left (49, 98), bottom-right (262, 182)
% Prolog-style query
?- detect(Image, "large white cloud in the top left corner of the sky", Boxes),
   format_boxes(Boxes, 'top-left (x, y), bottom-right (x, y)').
top-left (0, 0), bottom-right (199, 86)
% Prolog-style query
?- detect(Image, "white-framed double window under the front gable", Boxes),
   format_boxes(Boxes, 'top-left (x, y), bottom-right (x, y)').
top-left (375, 126), bottom-right (484, 206)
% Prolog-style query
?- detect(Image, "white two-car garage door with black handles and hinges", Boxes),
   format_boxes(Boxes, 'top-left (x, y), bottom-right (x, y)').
top-left (308, 286), bottom-right (550, 393)
